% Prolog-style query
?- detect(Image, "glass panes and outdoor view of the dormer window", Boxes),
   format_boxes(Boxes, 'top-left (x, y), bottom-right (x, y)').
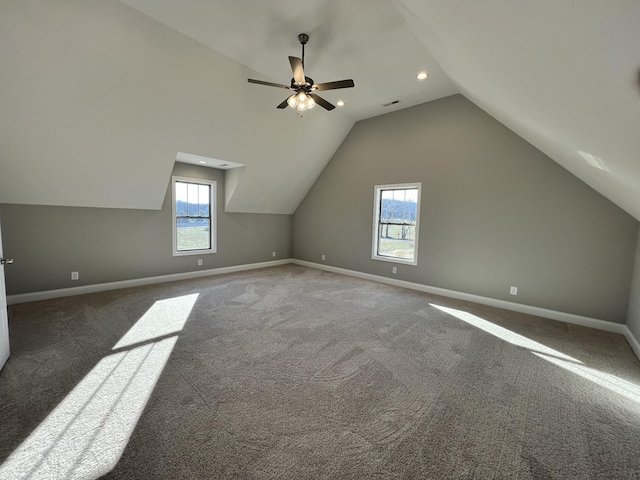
top-left (175, 181), bottom-right (211, 252)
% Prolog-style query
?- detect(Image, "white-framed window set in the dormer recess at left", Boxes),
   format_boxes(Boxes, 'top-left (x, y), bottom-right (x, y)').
top-left (171, 176), bottom-right (216, 256)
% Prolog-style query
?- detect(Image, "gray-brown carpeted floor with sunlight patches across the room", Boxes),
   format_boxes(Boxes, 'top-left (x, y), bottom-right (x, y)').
top-left (0, 265), bottom-right (640, 479)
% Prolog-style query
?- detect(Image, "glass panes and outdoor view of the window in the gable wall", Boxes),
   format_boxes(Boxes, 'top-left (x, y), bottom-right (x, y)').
top-left (376, 188), bottom-right (418, 260)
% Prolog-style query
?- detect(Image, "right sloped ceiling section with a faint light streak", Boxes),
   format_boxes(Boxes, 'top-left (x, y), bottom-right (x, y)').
top-left (398, 0), bottom-right (640, 219)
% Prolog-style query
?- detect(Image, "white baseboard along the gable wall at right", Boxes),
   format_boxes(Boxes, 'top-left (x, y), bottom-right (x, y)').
top-left (293, 259), bottom-right (628, 336)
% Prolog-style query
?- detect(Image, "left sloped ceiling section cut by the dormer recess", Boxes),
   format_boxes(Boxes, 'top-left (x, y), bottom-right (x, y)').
top-left (0, 0), bottom-right (354, 214)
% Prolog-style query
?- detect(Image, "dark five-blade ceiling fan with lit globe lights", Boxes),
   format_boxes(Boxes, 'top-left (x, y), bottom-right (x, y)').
top-left (248, 33), bottom-right (354, 112)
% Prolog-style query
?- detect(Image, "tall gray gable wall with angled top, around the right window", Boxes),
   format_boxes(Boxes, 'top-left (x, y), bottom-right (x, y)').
top-left (293, 95), bottom-right (638, 323)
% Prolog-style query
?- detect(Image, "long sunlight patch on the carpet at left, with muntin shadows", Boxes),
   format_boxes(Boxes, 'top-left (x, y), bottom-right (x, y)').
top-left (0, 294), bottom-right (198, 480)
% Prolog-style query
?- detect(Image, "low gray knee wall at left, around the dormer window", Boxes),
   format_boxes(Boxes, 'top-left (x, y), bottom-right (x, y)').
top-left (0, 164), bottom-right (292, 295)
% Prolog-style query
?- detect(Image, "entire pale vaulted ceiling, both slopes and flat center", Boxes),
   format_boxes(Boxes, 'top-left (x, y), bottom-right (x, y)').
top-left (0, 0), bottom-right (640, 219)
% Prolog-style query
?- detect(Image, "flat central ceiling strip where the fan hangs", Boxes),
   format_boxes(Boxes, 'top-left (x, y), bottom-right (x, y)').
top-left (121, 0), bottom-right (457, 120)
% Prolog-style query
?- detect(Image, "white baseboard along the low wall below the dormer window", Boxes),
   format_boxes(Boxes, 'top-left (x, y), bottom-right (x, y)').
top-left (7, 259), bottom-right (291, 305)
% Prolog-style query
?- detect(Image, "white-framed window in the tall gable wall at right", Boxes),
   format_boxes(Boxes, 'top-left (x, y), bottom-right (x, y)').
top-left (371, 183), bottom-right (422, 265)
